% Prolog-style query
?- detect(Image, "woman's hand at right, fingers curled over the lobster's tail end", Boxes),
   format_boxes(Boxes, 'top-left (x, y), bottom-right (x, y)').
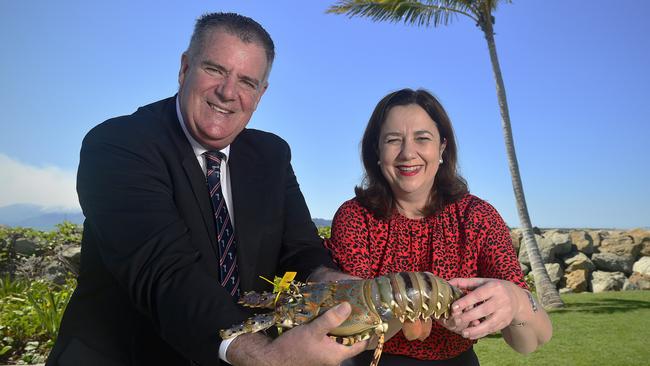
top-left (448, 278), bottom-right (524, 339)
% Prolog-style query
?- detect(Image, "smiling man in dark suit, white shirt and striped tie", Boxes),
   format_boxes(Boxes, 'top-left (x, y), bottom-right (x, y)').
top-left (47, 13), bottom-right (365, 366)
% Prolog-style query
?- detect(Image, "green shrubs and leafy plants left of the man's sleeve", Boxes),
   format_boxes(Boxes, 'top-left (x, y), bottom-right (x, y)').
top-left (0, 222), bottom-right (81, 364)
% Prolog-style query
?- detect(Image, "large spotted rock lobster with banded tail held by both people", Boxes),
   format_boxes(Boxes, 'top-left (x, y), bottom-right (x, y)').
top-left (220, 272), bottom-right (463, 366)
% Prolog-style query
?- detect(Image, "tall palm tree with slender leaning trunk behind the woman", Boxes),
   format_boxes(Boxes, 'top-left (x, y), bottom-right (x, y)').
top-left (327, 0), bottom-right (564, 308)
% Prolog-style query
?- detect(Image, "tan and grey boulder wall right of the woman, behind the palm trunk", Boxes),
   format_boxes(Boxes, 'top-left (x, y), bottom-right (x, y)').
top-left (511, 229), bottom-right (650, 293)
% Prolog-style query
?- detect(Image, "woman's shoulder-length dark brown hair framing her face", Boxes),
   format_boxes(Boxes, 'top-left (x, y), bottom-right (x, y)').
top-left (354, 89), bottom-right (468, 218)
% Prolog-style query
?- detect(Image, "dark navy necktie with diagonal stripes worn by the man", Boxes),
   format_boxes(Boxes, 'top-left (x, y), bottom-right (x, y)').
top-left (203, 150), bottom-right (239, 297)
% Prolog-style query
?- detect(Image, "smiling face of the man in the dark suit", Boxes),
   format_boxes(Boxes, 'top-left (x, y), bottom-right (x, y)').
top-left (178, 29), bottom-right (268, 149)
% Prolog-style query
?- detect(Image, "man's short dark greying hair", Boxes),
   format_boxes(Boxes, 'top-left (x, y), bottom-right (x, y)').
top-left (187, 13), bottom-right (275, 73)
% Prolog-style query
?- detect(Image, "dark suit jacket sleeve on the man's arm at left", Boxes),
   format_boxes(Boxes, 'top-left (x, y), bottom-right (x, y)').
top-left (77, 121), bottom-right (246, 365)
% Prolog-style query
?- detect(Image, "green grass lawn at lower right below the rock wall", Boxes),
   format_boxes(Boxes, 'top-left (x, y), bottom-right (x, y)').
top-left (475, 291), bottom-right (650, 366)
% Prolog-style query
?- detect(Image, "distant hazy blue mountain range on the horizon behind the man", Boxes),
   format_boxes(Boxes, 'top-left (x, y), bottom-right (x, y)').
top-left (0, 203), bottom-right (332, 231)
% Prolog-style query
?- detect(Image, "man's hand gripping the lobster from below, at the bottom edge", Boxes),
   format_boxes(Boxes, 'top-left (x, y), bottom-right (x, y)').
top-left (227, 303), bottom-right (368, 366)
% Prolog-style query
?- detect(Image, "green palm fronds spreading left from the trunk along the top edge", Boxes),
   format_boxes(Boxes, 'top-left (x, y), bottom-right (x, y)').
top-left (326, 0), bottom-right (480, 27)
